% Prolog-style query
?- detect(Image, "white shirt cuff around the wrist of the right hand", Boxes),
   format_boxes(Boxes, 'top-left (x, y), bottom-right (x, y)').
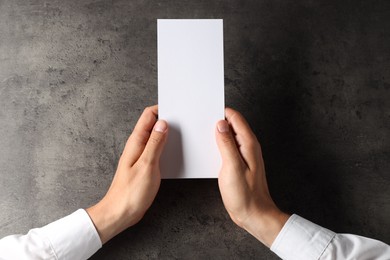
top-left (271, 214), bottom-right (336, 260)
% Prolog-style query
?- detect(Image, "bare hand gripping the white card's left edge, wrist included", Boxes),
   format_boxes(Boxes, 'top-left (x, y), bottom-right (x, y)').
top-left (87, 106), bottom-right (168, 244)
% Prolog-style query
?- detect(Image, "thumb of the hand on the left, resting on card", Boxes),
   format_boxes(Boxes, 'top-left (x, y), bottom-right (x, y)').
top-left (140, 120), bottom-right (168, 165)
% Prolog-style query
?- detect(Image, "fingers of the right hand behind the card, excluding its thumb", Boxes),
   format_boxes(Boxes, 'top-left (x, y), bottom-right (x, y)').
top-left (225, 108), bottom-right (261, 169)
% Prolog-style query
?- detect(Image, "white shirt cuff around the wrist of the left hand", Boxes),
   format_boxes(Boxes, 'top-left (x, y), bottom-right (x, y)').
top-left (40, 209), bottom-right (102, 259)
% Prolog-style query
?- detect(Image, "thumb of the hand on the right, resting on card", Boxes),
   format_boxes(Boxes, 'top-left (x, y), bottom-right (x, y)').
top-left (215, 120), bottom-right (242, 165)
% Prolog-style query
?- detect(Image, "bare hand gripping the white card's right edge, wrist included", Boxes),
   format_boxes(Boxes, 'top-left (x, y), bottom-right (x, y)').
top-left (216, 108), bottom-right (289, 247)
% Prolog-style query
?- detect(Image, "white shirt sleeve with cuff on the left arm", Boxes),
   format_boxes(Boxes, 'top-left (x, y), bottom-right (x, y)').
top-left (0, 209), bottom-right (102, 260)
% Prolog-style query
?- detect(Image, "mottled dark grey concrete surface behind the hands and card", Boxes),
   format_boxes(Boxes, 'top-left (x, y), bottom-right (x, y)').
top-left (0, 0), bottom-right (390, 259)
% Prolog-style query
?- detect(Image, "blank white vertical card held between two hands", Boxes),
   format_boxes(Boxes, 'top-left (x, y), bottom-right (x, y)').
top-left (157, 19), bottom-right (225, 179)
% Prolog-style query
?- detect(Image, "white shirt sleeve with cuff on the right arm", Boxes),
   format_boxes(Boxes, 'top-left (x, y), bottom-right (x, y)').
top-left (271, 215), bottom-right (390, 260)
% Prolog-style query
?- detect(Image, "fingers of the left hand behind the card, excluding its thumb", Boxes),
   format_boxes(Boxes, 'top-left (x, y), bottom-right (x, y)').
top-left (122, 105), bottom-right (158, 166)
